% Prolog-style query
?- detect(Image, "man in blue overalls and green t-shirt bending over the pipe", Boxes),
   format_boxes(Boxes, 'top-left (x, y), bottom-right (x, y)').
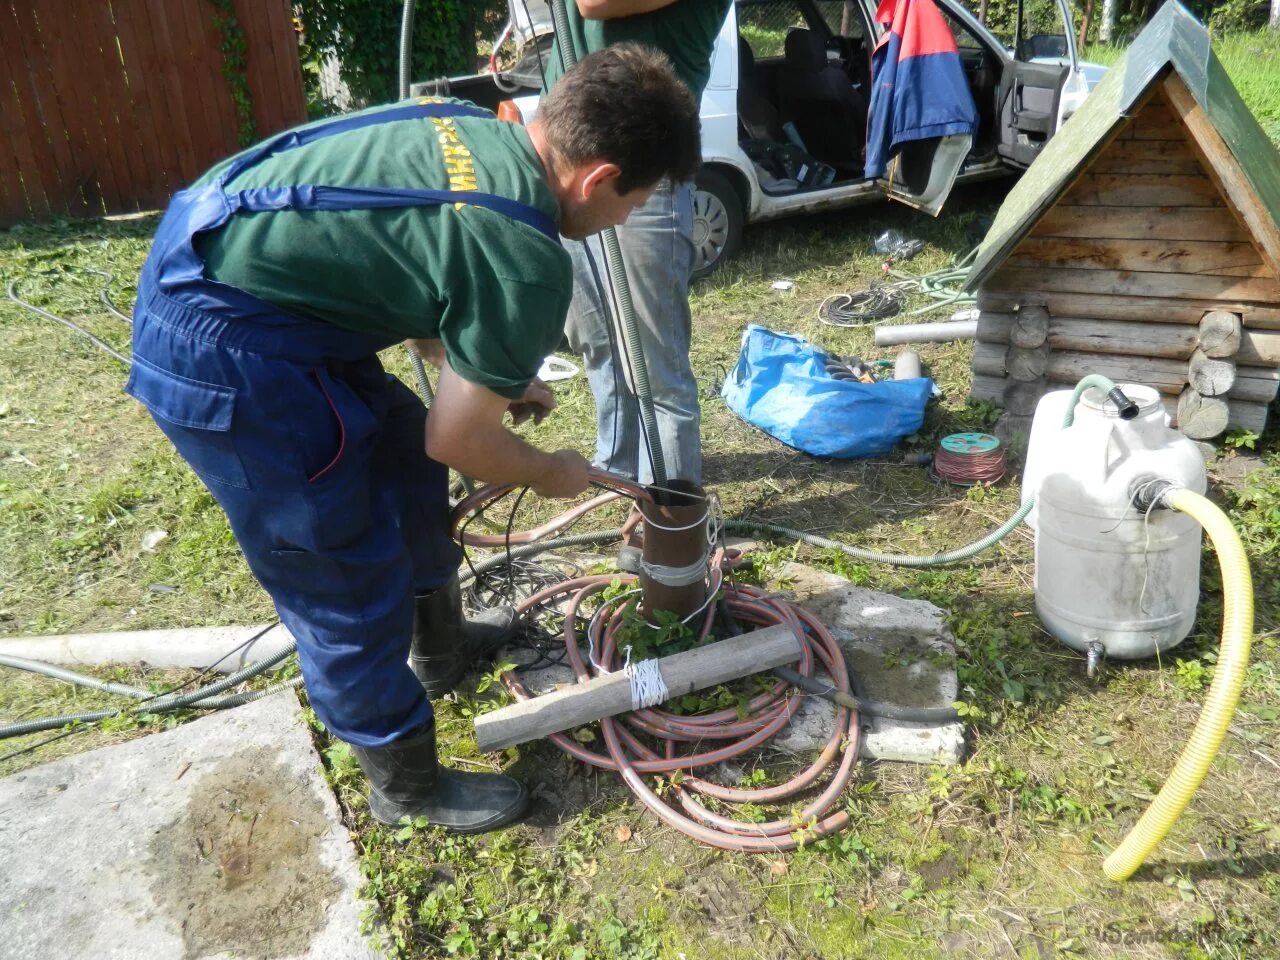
top-left (125, 45), bottom-right (699, 833)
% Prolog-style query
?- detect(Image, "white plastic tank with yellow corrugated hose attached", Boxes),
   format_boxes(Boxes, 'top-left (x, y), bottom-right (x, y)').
top-left (1023, 384), bottom-right (1204, 667)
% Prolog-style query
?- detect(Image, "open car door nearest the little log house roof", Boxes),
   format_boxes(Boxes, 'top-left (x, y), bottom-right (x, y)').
top-left (996, 0), bottom-right (1079, 166)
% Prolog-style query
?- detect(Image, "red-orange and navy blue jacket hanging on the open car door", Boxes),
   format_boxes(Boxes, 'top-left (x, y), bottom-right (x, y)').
top-left (867, 0), bottom-right (978, 178)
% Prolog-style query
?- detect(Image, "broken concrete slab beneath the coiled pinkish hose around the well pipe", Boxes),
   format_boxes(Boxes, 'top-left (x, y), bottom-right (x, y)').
top-left (513, 560), bottom-right (964, 763)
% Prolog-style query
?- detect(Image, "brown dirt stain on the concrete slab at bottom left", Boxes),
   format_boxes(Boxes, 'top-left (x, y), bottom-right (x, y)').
top-left (151, 749), bottom-right (342, 960)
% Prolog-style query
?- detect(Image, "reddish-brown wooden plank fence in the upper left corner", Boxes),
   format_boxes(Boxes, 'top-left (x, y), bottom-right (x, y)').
top-left (0, 0), bottom-right (306, 225)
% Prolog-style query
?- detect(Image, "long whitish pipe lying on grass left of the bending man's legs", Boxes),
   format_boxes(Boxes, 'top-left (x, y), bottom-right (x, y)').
top-left (0, 623), bottom-right (293, 673)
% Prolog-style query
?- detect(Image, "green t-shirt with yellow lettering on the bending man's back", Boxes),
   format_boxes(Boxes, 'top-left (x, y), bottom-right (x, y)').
top-left (196, 104), bottom-right (572, 398)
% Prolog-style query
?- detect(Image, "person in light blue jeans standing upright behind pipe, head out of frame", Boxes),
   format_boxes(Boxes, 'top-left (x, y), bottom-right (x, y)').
top-left (544, 0), bottom-right (732, 484)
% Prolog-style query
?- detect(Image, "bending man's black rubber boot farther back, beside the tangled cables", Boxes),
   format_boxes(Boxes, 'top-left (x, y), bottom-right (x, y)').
top-left (408, 576), bottom-right (520, 700)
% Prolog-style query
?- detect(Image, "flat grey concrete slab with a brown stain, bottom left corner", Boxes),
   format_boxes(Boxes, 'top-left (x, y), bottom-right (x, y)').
top-left (0, 694), bottom-right (378, 960)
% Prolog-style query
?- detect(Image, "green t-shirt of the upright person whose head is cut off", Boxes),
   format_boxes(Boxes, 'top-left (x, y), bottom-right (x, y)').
top-left (543, 0), bottom-right (733, 100)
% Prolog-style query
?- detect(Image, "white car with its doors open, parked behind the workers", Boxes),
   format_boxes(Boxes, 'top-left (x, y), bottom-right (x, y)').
top-left (435, 0), bottom-right (1106, 276)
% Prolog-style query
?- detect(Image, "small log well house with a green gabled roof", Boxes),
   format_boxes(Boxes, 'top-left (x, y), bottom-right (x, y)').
top-left (966, 0), bottom-right (1280, 439)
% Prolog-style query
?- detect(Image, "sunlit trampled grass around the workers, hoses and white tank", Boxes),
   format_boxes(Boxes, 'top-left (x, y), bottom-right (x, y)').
top-left (0, 188), bottom-right (1280, 959)
